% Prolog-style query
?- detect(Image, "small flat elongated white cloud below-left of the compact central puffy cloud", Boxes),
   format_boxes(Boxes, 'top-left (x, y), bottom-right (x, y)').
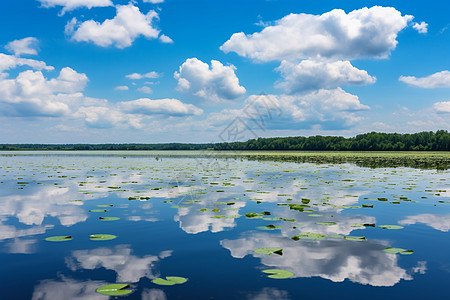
top-left (120, 98), bottom-right (203, 116)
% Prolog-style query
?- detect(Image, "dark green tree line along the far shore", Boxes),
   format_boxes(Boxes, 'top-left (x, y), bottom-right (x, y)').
top-left (0, 130), bottom-right (450, 151)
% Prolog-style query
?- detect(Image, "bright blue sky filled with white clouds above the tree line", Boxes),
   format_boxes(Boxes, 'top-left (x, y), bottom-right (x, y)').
top-left (0, 0), bottom-right (450, 143)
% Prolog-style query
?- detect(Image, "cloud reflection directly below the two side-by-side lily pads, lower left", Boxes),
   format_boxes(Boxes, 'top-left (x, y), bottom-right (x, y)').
top-left (66, 245), bottom-right (172, 282)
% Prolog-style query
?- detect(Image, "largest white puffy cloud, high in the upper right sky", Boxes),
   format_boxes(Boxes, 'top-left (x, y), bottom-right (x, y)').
top-left (220, 6), bottom-right (413, 62)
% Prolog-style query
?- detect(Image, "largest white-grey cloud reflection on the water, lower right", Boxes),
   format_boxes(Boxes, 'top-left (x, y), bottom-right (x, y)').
top-left (221, 233), bottom-right (412, 286)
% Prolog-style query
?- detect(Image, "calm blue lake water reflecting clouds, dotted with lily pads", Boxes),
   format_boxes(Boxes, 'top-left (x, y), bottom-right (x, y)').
top-left (0, 153), bottom-right (450, 300)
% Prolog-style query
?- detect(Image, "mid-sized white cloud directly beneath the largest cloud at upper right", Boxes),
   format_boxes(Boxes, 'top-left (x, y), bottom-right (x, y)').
top-left (276, 60), bottom-right (376, 94)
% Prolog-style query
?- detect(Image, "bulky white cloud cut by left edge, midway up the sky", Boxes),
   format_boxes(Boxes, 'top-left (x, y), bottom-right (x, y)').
top-left (0, 68), bottom-right (88, 117)
